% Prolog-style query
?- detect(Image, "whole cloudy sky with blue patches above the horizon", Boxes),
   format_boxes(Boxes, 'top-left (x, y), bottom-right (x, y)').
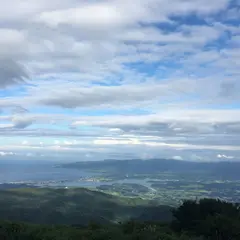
top-left (0, 0), bottom-right (240, 161)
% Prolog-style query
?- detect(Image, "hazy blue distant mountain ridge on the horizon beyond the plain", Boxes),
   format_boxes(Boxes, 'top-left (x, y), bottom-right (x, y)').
top-left (61, 159), bottom-right (240, 179)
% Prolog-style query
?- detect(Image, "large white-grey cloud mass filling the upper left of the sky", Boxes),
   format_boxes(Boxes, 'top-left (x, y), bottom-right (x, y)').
top-left (0, 0), bottom-right (235, 76)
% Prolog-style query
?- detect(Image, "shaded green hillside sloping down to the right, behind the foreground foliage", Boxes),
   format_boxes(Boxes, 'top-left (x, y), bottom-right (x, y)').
top-left (0, 188), bottom-right (172, 224)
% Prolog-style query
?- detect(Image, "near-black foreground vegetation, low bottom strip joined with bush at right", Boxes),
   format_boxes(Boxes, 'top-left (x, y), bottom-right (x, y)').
top-left (0, 199), bottom-right (240, 240)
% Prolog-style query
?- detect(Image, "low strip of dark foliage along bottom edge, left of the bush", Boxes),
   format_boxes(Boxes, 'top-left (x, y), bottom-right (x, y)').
top-left (0, 221), bottom-right (186, 240)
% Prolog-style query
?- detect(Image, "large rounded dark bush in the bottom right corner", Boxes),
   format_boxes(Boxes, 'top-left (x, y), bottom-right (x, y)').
top-left (172, 199), bottom-right (240, 240)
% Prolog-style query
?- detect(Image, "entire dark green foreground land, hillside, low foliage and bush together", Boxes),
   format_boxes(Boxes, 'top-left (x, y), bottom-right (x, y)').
top-left (0, 188), bottom-right (240, 240)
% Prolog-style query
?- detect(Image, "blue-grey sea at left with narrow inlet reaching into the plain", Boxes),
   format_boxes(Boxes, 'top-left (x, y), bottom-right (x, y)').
top-left (0, 161), bottom-right (151, 188)
